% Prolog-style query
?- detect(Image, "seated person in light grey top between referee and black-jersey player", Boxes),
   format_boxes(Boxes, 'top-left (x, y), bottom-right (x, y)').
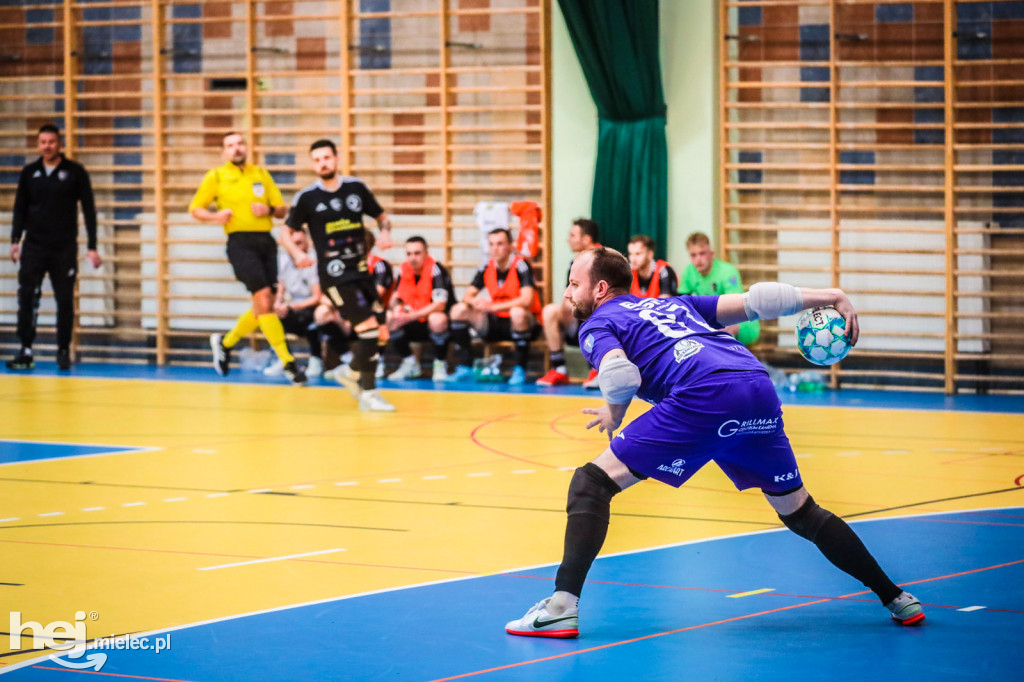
top-left (263, 230), bottom-right (324, 377)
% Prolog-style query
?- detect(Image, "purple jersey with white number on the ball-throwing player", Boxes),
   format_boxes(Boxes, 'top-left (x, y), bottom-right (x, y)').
top-left (580, 295), bottom-right (764, 404)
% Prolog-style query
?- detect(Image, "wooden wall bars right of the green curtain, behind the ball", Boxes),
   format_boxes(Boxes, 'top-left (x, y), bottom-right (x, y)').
top-left (719, 0), bottom-right (1024, 393)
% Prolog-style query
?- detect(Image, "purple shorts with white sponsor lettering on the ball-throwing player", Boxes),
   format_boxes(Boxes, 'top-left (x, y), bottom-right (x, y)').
top-left (611, 371), bottom-right (803, 493)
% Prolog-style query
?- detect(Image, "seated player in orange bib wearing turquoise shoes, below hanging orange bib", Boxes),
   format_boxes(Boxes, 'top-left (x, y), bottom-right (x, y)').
top-left (449, 227), bottom-right (541, 386)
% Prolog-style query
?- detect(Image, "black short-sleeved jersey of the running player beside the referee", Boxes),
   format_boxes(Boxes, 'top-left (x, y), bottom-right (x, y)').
top-left (285, 175), bottom-right (384, 289)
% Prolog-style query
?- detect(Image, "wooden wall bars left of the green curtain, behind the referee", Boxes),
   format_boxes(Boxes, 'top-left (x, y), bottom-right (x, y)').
top-left (0, 0), bottom-right (551, 365)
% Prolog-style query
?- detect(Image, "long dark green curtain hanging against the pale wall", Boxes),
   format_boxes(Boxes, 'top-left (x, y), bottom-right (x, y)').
top-left (558, 0), bottom-right (669, 258)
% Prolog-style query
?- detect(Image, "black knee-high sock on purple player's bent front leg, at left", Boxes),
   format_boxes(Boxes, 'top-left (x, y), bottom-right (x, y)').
top-left (555, 463), bottom-right (622, 597)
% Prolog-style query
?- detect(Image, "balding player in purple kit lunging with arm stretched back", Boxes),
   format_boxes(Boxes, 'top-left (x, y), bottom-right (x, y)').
top-left (506, 249), bottom-right (925, 637)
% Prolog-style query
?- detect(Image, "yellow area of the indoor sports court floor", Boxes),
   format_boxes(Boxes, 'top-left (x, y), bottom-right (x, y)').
top-left (0, 374), bottom-right (1024, 671)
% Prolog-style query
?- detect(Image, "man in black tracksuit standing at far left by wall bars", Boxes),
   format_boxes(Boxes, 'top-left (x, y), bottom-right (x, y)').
top-left (7, 124), bottom-right (102, 370)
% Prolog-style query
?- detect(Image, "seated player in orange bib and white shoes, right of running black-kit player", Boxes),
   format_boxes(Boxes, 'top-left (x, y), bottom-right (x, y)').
top-left (387, 237), bottom-right (455, 381)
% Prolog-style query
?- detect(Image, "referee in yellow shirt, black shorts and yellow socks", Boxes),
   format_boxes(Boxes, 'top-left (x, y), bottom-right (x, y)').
top-left (188, 132), bottom-right (306, 384)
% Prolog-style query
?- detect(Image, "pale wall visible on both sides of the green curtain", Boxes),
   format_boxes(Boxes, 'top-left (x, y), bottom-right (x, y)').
top-left (551, 0), bottom-right (720, 286)
